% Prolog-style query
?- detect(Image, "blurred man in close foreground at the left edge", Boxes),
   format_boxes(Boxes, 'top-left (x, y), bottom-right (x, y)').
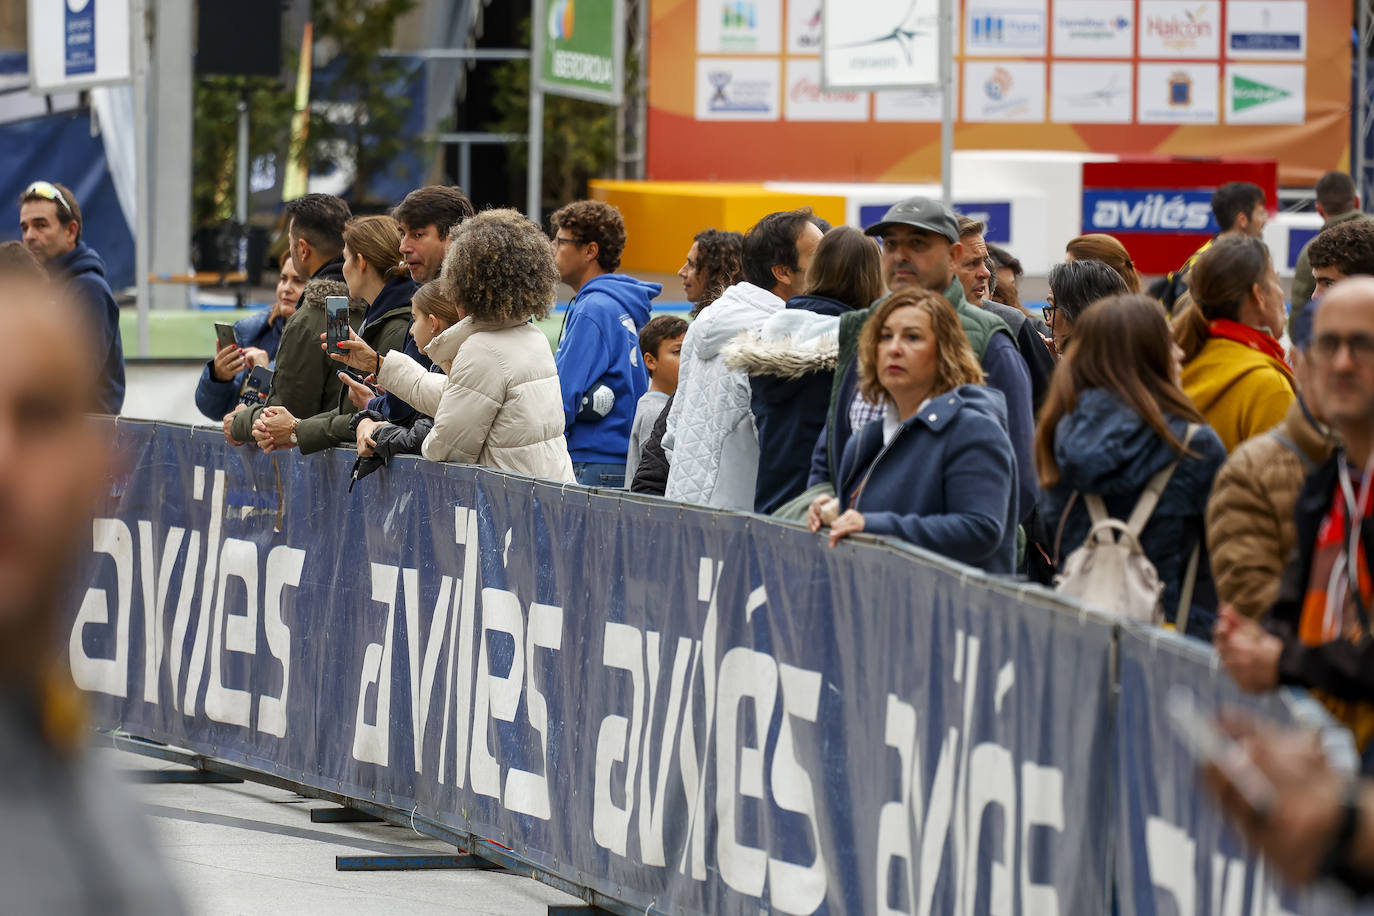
top-left (0, 268), bottom-right (180, 913)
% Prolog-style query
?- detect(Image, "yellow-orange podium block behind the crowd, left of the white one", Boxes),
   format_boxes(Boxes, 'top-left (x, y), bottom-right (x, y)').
top-left (591, 179), bottom-right (845, 273)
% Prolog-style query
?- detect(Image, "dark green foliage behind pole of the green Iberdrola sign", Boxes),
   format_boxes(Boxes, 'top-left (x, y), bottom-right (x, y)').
top-left (489, 19), bottom-right (616, 207)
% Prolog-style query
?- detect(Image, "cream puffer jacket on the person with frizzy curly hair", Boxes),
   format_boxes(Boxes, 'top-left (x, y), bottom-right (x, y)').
top-left (378, 317), bottom-right (574, 483)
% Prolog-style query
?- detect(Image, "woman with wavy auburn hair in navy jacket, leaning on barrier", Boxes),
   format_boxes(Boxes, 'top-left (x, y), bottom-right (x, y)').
top-left (807, 290), bottom-right (1017, 574)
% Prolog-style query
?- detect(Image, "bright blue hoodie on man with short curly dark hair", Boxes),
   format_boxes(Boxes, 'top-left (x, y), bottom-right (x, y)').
top-left (554, 273), bottom-right (664, 467)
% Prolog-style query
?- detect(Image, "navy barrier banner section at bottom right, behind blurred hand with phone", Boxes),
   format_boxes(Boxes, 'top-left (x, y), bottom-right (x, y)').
top-left (1116, 625), bottom-right (1367, 916)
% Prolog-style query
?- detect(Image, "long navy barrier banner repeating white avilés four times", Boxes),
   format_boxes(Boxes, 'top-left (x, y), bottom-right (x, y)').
top-left (67, 422), bottom-right (1116, 915)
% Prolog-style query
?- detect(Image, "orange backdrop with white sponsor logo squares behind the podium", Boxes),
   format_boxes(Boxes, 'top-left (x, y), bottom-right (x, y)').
top-left (647, 0), bottom-right (1352, 187)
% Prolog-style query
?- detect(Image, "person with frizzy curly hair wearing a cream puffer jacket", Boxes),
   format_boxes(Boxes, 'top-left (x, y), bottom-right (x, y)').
top-left (330, 210), bottom-right (574, 483)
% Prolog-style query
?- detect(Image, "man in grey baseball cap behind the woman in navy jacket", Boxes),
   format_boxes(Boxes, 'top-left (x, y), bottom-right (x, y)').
top-left (811, 198), bottom-right (1037, 532)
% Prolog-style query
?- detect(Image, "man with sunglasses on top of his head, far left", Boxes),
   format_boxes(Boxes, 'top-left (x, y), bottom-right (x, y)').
top-left (19, 181), bottom-right (124, 413)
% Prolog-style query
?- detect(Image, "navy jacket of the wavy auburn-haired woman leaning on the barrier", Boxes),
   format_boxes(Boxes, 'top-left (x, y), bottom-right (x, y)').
top-left (840, 385), bottom-right (1017, 575)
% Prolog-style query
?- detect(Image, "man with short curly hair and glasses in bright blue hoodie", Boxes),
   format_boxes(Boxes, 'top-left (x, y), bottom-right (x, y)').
top-left (551, 201), bottom-right (664, 489)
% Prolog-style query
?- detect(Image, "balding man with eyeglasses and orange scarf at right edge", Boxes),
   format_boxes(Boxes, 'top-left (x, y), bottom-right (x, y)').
top-left (1215, 277), bottom-right (1374, 772)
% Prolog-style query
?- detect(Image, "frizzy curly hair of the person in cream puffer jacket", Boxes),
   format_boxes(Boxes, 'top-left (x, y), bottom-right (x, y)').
top-left (440, 210), bottom-right (558, 321)
